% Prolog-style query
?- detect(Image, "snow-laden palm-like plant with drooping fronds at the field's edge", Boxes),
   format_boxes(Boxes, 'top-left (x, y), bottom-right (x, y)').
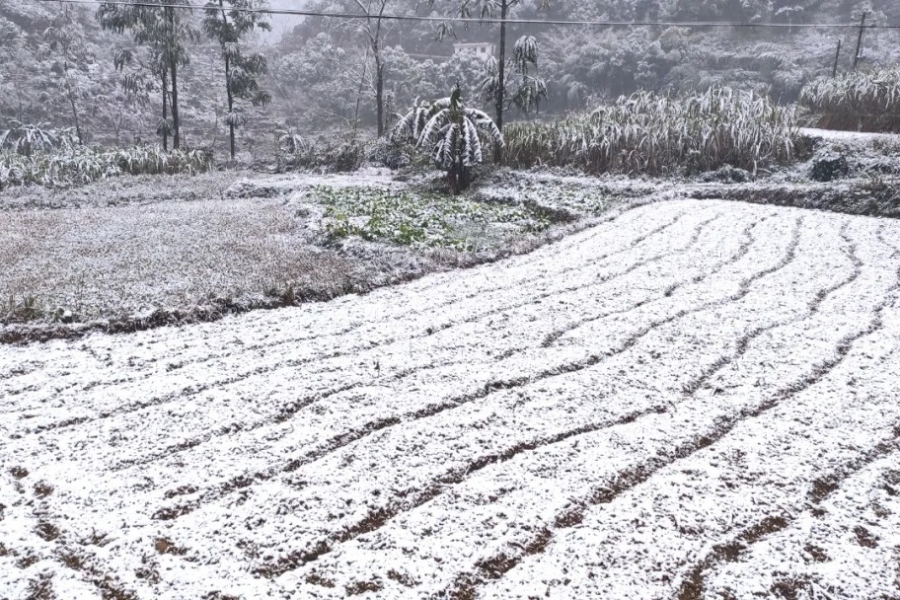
top-left (393, 85), bottom-right (504, 193)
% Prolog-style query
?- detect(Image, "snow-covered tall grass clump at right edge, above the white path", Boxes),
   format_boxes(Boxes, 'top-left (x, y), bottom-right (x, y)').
top-left (800, 66), bottom-right (900, 132)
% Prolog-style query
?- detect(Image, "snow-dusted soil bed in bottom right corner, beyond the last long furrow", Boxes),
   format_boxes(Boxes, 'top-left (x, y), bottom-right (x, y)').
top-left (704, 451), bottom-right (900, 600)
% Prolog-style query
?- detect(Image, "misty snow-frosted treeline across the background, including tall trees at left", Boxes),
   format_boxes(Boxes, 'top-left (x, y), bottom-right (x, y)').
top-left (0, 0), bottom-right (900, 154)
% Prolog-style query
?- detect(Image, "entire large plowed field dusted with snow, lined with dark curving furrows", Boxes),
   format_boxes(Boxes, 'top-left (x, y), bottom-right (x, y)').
top-left (0, 201), bottom-right (900, 600)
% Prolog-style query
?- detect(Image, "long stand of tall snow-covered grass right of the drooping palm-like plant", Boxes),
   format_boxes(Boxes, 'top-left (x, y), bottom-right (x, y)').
top-left (505, 88), bottom-right (799, 175)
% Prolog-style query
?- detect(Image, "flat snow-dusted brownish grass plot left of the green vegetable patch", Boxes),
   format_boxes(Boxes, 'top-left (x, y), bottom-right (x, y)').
top-left (0, 200), bottom-right (365, 323)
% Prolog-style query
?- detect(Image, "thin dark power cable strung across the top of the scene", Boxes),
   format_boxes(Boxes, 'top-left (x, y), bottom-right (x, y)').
top-left (29, 0), bottom-right (900, 29)
